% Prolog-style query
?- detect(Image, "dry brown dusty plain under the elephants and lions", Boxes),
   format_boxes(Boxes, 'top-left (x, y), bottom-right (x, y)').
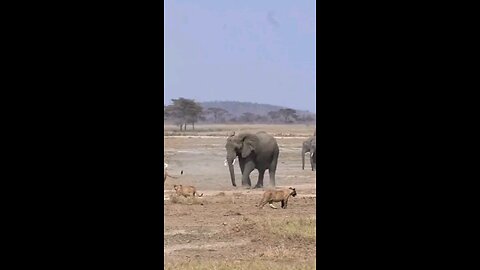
top-left (164, 125), bottom-right (316, 269)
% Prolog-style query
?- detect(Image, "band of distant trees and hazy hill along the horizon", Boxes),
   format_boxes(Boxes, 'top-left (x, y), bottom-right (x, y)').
top-left (164, 98), bottom-right (315, 130)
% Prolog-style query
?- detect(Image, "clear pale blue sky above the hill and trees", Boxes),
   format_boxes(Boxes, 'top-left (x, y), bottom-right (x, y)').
top-left (164, 0), bottom-right (316, 112)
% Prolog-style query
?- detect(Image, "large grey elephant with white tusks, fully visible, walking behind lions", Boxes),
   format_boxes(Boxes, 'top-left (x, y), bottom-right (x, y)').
top-left (225, 131), bottom-right (280, 188)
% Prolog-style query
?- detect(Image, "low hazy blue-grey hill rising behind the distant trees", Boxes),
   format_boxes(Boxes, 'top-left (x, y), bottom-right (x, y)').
top-left (199, 101), bottom-right (315, 116)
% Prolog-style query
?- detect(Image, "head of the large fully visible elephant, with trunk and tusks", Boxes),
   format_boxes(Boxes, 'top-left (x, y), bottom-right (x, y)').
top-left (225, 132), bottom-right (258, 186)
